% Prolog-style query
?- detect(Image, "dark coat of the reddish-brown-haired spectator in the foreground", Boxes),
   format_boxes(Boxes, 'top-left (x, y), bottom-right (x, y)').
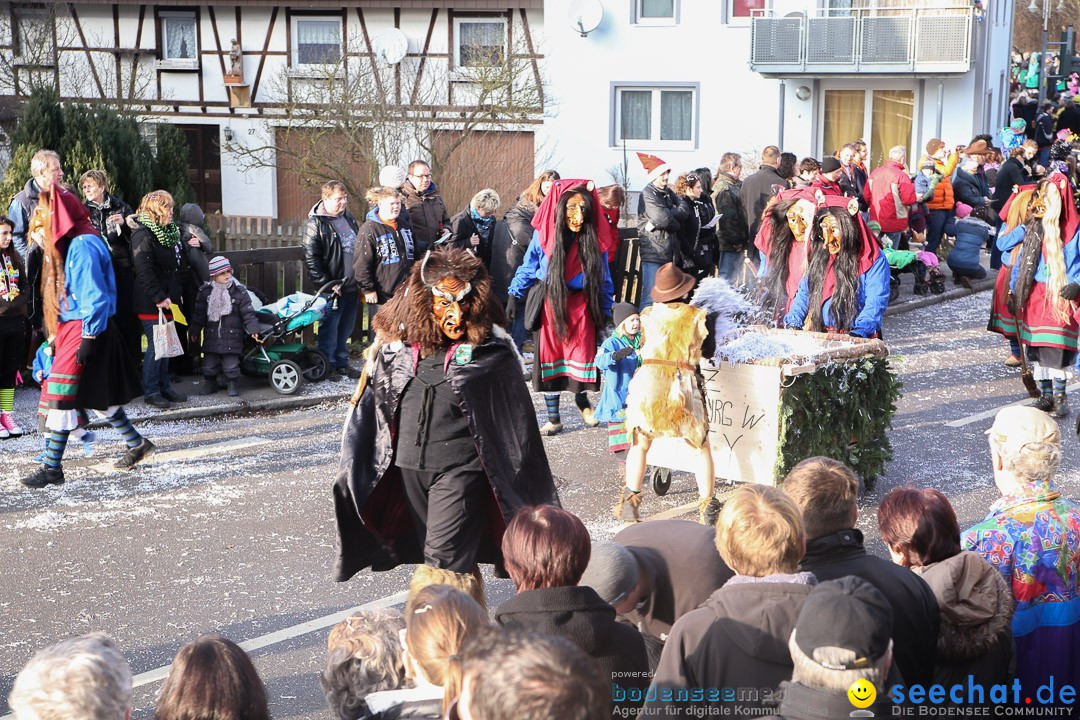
top-left (495, 586), bottom-right (649, 708)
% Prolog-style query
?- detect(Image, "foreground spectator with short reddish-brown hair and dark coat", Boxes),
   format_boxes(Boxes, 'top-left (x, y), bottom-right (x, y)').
top-left (495, 505), bottom-right (649, 709)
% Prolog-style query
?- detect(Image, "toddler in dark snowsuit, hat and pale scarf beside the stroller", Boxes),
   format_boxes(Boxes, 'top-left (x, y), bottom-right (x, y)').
top-left (191, 255), bottom-right (259, 397)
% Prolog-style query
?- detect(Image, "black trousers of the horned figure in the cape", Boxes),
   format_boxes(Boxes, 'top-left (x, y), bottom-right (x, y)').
top-left (400, 458), bottom-right (491, 573)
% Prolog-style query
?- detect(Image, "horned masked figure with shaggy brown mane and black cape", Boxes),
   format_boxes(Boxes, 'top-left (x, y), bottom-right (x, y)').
top-left (334, 248), bottom-right (558, 596)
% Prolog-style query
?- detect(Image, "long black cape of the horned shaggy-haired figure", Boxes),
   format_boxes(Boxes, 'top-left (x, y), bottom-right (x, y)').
top-left (334, 330), bottom-right (559, 582)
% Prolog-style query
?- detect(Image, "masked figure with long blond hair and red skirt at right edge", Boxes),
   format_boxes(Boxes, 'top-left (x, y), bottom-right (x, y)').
top-left (998, 161), bottom-right (1080, 418)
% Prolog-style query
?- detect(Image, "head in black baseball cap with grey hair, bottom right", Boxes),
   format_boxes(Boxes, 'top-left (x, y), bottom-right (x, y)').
top-left (792, 575), bottom-right (892, 670)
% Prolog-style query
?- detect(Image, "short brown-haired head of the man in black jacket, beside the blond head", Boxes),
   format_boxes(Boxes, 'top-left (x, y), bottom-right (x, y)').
top-left (781, 458), bottom-right (859, 540)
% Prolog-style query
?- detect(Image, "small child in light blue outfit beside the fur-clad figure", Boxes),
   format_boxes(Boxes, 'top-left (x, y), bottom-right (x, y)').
top-left (596, 302), bottom-right (642, 462)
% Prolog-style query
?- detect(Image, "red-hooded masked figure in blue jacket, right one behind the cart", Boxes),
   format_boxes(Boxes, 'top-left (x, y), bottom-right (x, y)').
top-left (784, 196), bottom-right (890, 338)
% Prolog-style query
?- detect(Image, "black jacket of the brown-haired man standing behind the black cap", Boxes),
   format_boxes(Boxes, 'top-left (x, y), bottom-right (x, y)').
top-left (799, 529), bottom-right (941, 688)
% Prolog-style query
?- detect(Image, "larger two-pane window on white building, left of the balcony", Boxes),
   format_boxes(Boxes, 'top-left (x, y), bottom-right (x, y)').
top-left (613, 85), bottom-right (698, 148)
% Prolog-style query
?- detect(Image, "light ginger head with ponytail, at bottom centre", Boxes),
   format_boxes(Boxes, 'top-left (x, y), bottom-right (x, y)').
top-left (403, 585), bottom-right (488, 714)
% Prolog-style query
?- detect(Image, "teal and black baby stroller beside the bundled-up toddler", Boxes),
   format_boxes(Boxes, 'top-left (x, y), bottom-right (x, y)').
top-left (240, 280), bottom-right (341, 395)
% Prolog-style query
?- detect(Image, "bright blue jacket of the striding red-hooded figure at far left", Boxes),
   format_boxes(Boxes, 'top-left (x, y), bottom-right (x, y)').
top-left (59, 233), bottom-right (117, 337)
